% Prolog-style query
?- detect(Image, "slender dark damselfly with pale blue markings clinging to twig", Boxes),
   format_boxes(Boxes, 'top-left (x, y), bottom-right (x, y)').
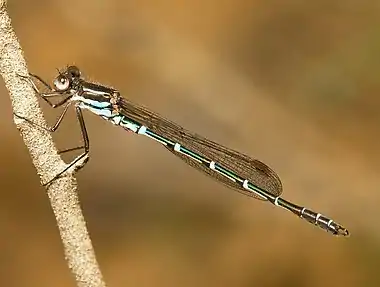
top-left (17, 66), bottom-right (349, 236)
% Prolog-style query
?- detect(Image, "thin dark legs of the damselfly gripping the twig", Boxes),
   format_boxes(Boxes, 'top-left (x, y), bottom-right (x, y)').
top-left (14, 74), bottom-right (90, 186)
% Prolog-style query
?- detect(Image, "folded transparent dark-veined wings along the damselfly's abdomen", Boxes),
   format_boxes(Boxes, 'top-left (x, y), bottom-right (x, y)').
top-left (119, 98), bottom-right (282, 199)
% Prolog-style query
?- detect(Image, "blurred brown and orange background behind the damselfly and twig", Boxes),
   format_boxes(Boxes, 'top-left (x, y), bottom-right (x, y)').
top-left (0, 0), bottom-right (380, 287)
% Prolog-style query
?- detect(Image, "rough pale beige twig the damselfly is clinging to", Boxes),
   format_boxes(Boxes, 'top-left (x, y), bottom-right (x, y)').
top-left (0, 0), bottom-right (105, 287)
